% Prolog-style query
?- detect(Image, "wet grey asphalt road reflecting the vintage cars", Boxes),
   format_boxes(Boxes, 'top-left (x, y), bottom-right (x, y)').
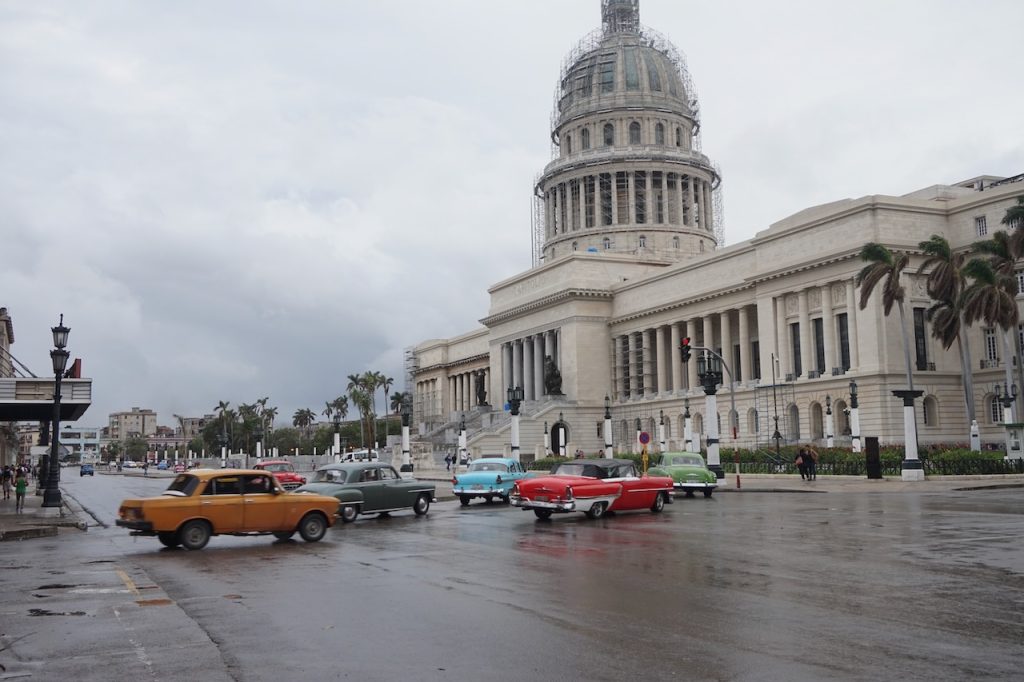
top-left (0, 476), bottom-right (1024, 680)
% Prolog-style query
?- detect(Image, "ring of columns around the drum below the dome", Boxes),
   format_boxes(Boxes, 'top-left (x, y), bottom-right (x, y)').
top-left (545, 171), bottom-right (715, 238)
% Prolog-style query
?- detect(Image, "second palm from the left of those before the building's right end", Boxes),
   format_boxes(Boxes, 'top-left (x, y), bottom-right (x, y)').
top-left (918, 235), bottom-right (977, 438)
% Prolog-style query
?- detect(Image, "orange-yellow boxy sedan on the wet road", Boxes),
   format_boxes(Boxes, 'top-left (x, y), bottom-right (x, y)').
top-left (117, 469), bottom-right (338, 550)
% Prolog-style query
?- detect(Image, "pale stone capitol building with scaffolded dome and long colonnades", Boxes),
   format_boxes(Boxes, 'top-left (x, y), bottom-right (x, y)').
top-left (406, 0), bottom-right (1024, 460)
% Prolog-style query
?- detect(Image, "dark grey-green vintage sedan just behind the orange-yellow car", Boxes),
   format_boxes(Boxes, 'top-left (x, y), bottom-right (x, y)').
top-left (294, 462), bottom-right (434, 523)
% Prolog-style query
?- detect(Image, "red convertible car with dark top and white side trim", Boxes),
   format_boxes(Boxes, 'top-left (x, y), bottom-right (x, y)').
top-left (509, 460), bottom-right (672, 519)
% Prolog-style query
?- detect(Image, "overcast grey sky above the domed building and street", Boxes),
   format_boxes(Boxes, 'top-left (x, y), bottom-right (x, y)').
top-left (0, 0), bottom-right (1024, 426)
